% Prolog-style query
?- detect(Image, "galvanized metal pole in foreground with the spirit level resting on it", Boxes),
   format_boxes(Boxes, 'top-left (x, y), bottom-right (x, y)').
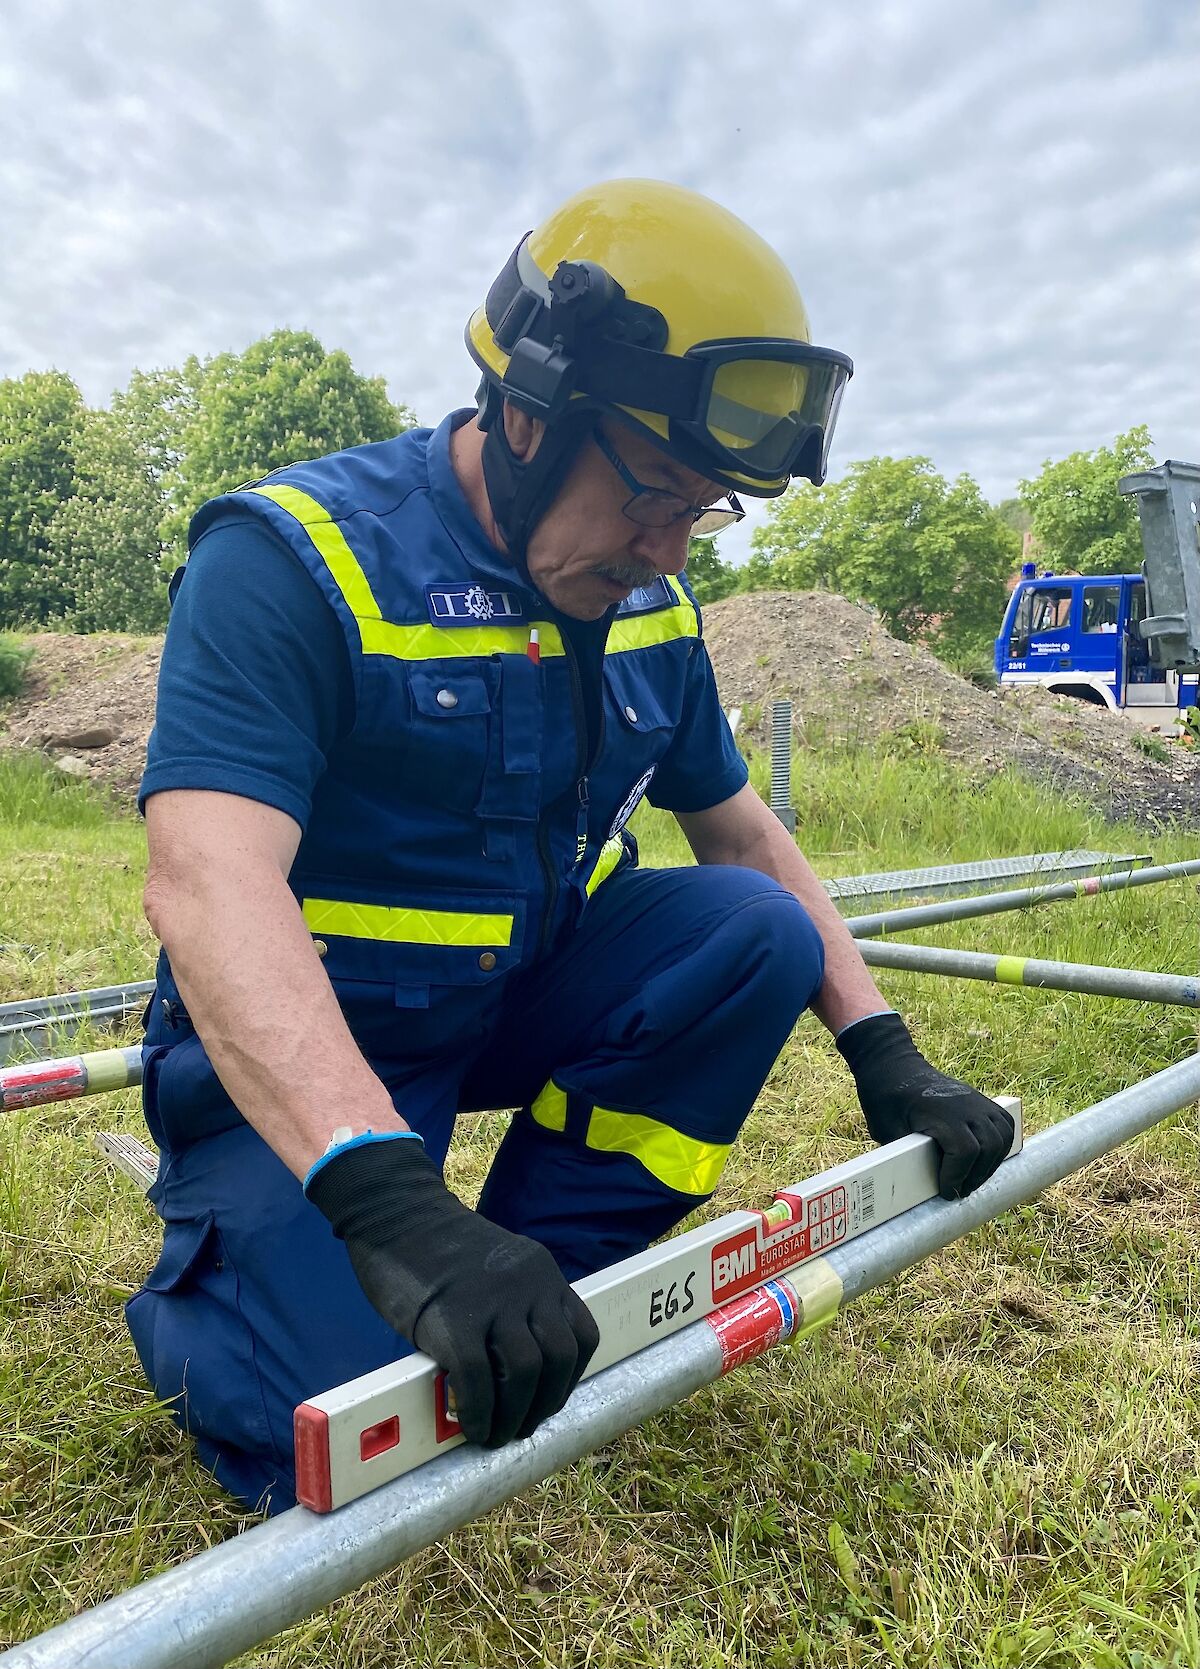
top-left (9, 1055), bottom-right (1200, 1669)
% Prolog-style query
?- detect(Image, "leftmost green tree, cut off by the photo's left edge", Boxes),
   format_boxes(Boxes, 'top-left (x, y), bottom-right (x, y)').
top-left (0, 371), bottom-right (83, 626)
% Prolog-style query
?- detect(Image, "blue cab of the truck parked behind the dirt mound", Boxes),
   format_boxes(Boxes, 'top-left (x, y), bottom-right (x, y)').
top-left (995, 562), bottom-right (1197, 723)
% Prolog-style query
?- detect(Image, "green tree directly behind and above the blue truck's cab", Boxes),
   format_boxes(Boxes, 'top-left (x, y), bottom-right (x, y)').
top-left (1020, 424), bottom-right (1155, 574)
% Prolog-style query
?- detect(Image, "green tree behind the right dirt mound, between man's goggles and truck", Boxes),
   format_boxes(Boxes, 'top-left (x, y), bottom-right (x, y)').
top-left (746, 457), bottom-right (1020, 651)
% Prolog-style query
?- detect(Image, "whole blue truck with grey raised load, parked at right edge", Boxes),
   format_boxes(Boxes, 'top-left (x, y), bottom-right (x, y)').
top-left (995, 461), bottom-right (1200, 726)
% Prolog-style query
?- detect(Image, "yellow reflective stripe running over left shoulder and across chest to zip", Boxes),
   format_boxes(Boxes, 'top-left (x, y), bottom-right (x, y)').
top-left (247, 486), bottom-right (566, 661)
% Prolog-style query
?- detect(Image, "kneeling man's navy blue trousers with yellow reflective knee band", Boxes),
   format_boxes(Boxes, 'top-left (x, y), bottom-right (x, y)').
top-left (127, 866), bottom-right (824, 1510)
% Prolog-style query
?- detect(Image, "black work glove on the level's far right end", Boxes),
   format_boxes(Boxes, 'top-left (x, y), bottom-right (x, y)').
top-left (838, 1015), bottom-right (1016, 1200)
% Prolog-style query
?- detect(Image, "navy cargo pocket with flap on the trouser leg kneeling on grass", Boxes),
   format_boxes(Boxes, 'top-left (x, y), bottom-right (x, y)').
top-left (125, 1212), bottom-right (282, 1465)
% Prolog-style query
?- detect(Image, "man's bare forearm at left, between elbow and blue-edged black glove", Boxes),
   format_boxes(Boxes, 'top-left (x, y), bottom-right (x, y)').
top-left (147, 865), bottom-right (407, 1177)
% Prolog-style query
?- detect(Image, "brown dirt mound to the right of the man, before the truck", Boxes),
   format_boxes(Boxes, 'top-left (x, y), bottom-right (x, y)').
top-left (704, 591), bottom-right (1200, 828)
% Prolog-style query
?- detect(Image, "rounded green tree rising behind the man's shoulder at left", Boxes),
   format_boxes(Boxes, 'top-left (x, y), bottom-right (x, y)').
top-left (167, 330), bottom-right (416, 551)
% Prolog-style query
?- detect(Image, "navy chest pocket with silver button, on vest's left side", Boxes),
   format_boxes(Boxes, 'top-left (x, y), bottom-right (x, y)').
top-left (402, 663), bottom-right (496, 811)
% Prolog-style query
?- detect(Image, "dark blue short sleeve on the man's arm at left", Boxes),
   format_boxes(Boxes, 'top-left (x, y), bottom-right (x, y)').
top-left (139, 516), bottom-right (354, 828)
